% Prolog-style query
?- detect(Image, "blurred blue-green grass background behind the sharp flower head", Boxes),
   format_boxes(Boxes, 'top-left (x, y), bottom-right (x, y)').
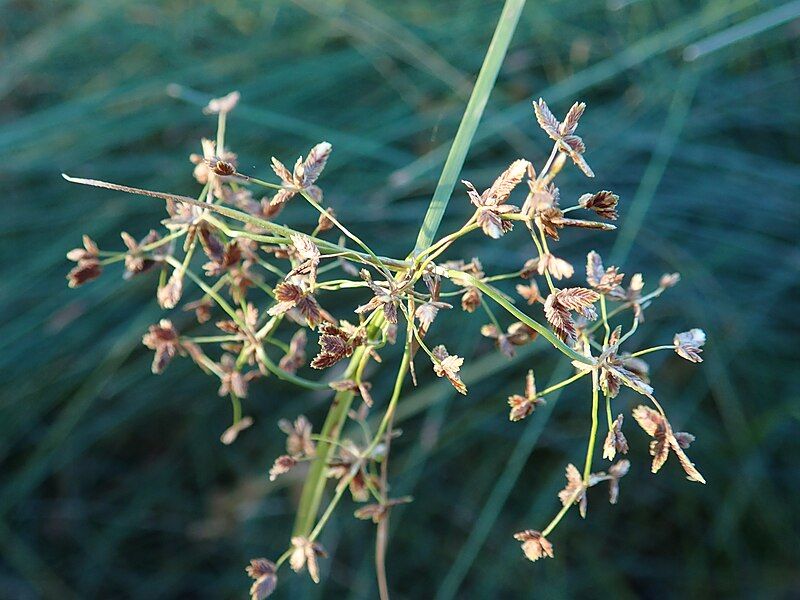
top-left (0, 0), bottom-right (800, 599)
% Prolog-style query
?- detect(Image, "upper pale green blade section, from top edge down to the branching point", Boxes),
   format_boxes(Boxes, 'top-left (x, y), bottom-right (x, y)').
top-left (413, 0), bottom-right (525, 255)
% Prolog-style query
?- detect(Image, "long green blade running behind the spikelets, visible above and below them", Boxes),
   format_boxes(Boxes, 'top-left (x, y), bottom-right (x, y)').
top-left (294, 0), bottom-right (525, 535)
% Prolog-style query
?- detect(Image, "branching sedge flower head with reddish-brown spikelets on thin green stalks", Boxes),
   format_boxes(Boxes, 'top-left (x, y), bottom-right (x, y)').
top-left (65, 92), bottom-right (705, 599)
